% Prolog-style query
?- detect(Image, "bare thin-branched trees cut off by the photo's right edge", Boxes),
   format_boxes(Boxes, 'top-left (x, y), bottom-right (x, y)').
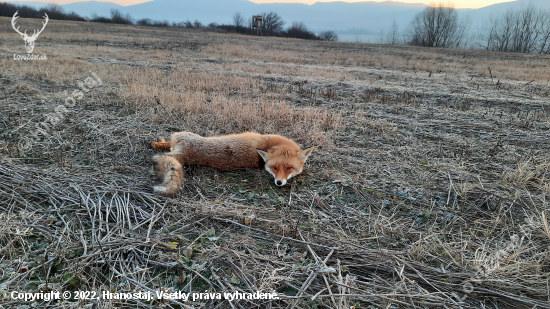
top-left (484, 4), bottom-right (550, 53)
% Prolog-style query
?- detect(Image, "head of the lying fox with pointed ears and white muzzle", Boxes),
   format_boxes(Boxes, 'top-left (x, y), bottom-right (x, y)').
top-left (256, 146), bottom-right (315, 186)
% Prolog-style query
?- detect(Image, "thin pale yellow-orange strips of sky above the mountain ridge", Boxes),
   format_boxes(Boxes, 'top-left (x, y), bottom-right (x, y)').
top-left (9, 0), bottom-right (512, 9)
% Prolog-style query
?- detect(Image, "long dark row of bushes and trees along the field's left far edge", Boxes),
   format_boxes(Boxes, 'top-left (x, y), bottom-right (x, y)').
top-left (0, 2), bottom-right (338, 41)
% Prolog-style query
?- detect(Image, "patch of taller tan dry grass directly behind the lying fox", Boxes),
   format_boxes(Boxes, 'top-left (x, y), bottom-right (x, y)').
top-left (123, 68), bottom-right (341, 145)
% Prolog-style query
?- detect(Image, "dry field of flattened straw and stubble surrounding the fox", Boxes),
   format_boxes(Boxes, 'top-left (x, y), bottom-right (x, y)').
top-left (0, 18), bottom-right (550, 308)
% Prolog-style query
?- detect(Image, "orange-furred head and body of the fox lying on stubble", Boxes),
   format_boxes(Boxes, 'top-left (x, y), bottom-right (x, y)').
top-left (151, 132), bottom-right (315, 192)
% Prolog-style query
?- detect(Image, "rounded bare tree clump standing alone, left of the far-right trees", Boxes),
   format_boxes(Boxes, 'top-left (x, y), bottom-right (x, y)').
top-left (410, 2), bottom-right (468, 47)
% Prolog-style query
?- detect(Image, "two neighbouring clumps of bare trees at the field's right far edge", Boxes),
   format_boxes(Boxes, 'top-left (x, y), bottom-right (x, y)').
top-left (378, 3), bottom-right (550, 54)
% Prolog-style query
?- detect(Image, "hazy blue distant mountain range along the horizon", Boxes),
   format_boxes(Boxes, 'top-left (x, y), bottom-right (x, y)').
top-left (7, 0), bottom-right (550, 41)
